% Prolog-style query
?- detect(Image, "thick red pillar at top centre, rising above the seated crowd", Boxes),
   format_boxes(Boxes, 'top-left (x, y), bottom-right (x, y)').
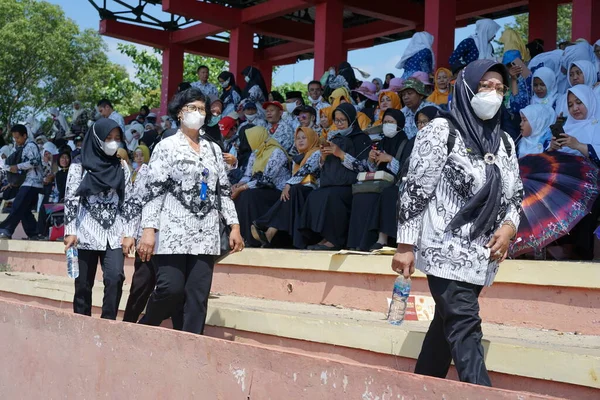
top-left (314, 0), bottom-right (346, 79)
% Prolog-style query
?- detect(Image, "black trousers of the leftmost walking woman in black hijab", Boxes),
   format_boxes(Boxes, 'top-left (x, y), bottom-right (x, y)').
top-left (73, 247), bottom-right (125, 319)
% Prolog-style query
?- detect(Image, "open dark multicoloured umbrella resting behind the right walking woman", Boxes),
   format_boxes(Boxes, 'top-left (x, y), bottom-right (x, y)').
top-left (509, 152), bottom-right (598, 257)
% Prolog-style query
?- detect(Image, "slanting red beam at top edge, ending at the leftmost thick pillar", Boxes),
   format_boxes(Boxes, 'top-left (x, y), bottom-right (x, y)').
top-left (162, 0), bottom-right (242, 30)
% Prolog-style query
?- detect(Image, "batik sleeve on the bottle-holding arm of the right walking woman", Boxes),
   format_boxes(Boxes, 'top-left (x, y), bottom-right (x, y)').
top-left (397, 119), bottom-right (449, 245)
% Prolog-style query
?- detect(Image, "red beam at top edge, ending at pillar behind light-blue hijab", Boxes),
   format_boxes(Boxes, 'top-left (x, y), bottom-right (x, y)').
top-left (343, 0), bottom-right (424, 25)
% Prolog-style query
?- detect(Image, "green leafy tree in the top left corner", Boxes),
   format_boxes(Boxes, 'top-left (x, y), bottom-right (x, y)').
top-left (0, 0), bottom-right (131, 125)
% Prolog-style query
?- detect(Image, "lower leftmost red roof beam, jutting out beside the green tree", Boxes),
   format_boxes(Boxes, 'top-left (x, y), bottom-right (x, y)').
top-left (99, 19), bottom-right (169, 49)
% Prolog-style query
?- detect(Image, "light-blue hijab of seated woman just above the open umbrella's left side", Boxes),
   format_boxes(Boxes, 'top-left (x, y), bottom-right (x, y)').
top-left (519, 104), bottom-right (556, 158)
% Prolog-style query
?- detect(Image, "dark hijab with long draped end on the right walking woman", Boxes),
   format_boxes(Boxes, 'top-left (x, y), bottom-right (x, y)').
top-left (442, 60), bottom-right (508, 240)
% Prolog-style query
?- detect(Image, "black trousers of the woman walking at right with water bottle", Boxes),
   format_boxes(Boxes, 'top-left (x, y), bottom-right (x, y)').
top-left (415, 275), bottom-right (492, 386)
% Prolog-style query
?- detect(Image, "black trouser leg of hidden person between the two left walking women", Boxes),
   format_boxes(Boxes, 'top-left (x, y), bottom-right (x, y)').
top-left (123, 253), bottom-right (156, 323)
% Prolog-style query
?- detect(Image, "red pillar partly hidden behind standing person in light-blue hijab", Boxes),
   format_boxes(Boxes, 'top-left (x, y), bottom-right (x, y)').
top-left (425, 0), bottom-right (456, 68)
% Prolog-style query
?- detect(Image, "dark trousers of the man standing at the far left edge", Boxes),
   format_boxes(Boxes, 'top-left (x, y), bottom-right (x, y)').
top-left (0, 186), bottom-right (40, 237)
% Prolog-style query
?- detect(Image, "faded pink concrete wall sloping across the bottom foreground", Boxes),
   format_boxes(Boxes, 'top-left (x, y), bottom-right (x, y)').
top-left (0, 301), bottom-right (549, 400)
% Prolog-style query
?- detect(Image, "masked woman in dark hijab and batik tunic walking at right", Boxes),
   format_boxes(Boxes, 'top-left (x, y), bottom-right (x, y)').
top-left (392, 60), bottom-right (523, 386)
